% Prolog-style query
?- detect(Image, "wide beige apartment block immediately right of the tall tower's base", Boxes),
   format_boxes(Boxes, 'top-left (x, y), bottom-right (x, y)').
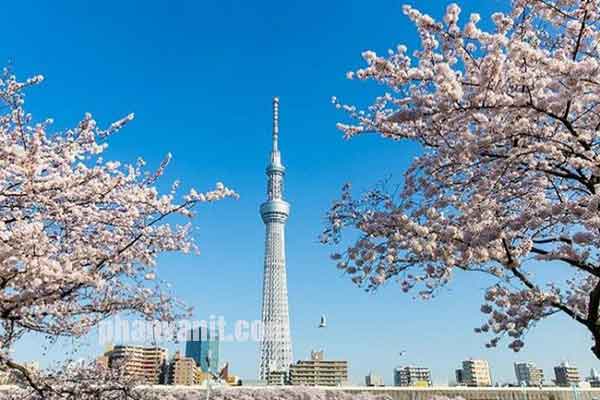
top-left (289, 351), bottom-right (348, 386)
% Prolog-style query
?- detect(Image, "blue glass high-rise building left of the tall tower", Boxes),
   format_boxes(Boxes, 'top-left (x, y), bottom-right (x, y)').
top-left (185, 326), bottom-right (220, 374)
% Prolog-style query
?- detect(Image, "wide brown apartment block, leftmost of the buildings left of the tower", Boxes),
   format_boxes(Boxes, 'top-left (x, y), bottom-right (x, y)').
top-left (105, 346), bottom-right (167, 385)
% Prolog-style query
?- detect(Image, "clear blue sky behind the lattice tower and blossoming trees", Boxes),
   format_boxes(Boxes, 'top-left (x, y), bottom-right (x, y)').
top-left (5, 0), bottom-right (599, 384)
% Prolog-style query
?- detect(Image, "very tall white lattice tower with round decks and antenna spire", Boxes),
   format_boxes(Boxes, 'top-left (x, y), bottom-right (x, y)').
top-left (259, 97), bottom-right (292, 379)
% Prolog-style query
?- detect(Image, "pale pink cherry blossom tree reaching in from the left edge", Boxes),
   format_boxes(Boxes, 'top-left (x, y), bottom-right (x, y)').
top-left (0, 71), bottom-right (236, 398)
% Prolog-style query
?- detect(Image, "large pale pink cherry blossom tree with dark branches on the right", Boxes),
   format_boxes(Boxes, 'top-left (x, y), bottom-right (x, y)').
top-left (322, 0), bottom-right (600, 358)
